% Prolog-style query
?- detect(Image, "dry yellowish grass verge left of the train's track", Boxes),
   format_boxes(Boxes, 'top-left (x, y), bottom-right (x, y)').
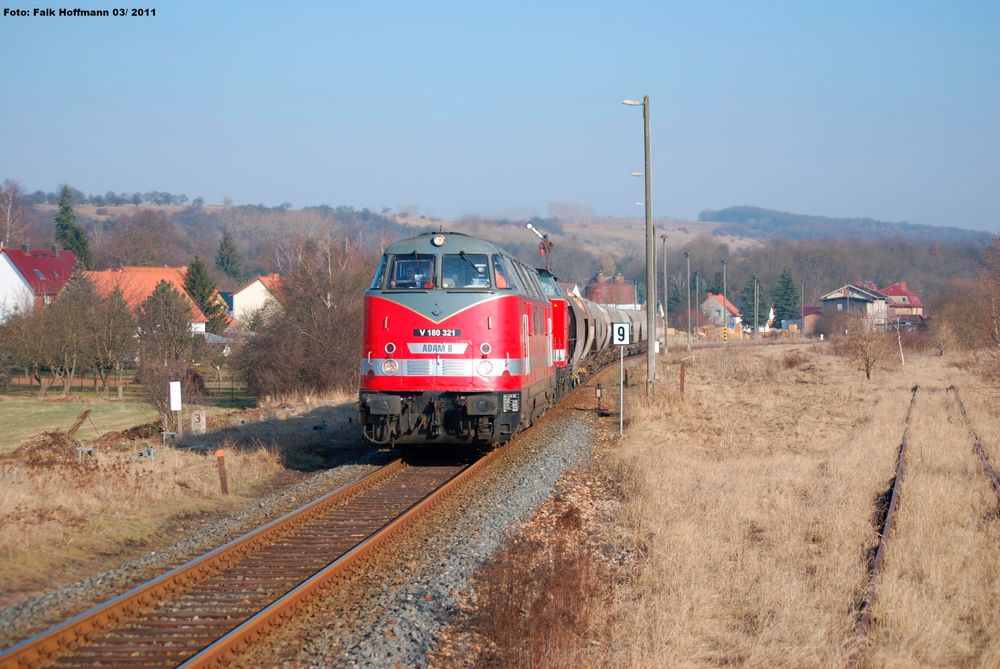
top-left (0, 444), bottom-right (282, 606)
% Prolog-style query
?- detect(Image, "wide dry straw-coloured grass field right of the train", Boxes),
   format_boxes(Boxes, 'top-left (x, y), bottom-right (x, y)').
top-left (444, 344), bottom-right (1000, 667)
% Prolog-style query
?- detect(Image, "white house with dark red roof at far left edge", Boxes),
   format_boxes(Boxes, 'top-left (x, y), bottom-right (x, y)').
top-left (0, 244), bottom-right (76, 323)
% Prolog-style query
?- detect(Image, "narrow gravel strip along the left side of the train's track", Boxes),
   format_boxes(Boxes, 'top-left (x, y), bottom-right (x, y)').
top-left (0, 448), bottom-right (394, 648)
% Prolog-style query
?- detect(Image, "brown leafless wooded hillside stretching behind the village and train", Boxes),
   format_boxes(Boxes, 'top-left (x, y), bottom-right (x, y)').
top-left (8, 184), bottom-right (991, 313)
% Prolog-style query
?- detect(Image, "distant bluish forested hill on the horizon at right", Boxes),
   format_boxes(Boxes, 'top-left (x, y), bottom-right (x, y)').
top-left (698, 206), bottom-right (992, 245)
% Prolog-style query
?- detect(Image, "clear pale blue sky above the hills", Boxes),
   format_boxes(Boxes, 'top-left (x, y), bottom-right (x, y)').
top-left (0, 0), bottom-right (1000, 232)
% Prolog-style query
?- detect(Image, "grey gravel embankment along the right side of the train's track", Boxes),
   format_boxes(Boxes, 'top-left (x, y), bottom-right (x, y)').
top-left (243, 410), bottom-right (594, 667)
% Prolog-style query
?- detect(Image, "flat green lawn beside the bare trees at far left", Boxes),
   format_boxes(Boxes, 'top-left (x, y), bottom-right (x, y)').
top-left (0, 391), bottom-right (156, 454)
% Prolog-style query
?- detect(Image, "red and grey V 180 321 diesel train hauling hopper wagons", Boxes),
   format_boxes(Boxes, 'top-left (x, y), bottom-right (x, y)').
top-left (358, 231), bottom-right (647, 446)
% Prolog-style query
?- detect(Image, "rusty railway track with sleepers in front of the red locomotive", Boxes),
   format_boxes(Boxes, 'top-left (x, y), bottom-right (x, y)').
top-left (0, 448), bottom-right (505, 668)
